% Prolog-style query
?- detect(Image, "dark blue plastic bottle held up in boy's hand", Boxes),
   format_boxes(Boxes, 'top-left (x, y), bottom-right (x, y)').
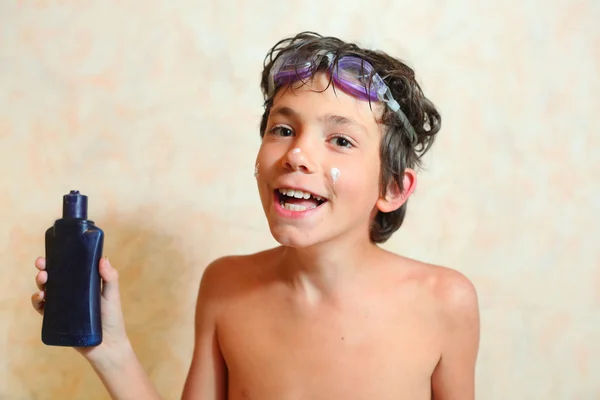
top-left (42, 190), bottom-right (104, 347)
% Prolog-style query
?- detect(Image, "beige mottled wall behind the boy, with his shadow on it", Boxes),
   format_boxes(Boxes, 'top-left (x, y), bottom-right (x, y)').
top-left (0, 0), bottom-right (600, 400)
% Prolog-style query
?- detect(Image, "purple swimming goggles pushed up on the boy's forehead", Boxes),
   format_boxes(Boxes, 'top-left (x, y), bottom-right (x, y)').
top-left (268, 52), bottom-right (417, 141)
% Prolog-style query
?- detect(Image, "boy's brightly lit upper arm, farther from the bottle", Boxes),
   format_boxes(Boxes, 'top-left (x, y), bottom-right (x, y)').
top-left (431, 270), bottom-right (480, 400)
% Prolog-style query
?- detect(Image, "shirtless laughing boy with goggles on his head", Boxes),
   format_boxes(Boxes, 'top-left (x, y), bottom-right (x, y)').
top-left (32, 32), bottom-right (479, 400)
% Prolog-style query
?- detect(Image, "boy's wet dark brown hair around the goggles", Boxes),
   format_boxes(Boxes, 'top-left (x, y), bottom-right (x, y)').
top-left (260, 32), bottom-right (441, 243)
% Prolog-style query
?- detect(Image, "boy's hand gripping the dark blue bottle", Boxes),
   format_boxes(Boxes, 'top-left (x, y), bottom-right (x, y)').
top-left (31, 257), bottom-right (131, 367)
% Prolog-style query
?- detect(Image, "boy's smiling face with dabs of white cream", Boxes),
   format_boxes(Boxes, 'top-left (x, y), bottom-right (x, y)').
top-left (256, 73), bottom-right (396, 247)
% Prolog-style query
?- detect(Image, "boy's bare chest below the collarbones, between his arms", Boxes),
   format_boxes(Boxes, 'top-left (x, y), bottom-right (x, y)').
top-left (219, 290), bottom-right (439, 400)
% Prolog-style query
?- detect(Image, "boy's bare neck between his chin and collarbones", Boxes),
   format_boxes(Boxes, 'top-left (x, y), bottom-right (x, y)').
top-left (281, 233), bottom-right (380, 302)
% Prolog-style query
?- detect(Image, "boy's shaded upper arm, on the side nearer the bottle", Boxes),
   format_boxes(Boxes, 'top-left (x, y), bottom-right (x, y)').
top-left (181, 259), bottom-right (227, 400)
